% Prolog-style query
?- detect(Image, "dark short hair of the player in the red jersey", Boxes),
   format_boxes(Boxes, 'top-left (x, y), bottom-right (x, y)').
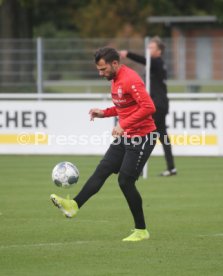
top-left (94, 47), bottom-right (120, 64)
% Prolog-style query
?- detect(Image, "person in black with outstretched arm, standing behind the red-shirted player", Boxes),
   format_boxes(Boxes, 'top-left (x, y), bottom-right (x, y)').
top-left (120, 36), bottom-right (177, 176)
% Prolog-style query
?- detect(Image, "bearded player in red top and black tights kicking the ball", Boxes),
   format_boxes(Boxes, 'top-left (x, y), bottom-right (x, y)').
top-left (50, 47), bottom-right (157, 242)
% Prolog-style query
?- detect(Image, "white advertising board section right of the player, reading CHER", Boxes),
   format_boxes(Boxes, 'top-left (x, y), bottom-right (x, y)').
top-left (154, 100), bottom-right (223, 156)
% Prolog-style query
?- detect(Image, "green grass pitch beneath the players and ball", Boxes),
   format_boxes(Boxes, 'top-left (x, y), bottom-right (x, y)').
top-left (0, 155), bottom-right (223, 276)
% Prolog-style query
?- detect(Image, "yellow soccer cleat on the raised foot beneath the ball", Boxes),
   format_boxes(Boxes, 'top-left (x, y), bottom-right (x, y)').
top-left (50, 194), bottom-right (79, 218)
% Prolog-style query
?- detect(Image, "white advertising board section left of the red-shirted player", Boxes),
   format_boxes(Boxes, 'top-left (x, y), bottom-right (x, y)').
top-left (0, 101), bottom-right (114, 154)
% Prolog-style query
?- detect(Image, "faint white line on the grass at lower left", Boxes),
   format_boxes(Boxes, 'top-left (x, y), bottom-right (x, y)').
top-left (0, 241), bottom-right (96, 250)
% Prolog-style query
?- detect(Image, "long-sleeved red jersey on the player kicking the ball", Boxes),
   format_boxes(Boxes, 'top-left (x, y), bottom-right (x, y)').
top-left (103, 65), bottom-right (156, 137)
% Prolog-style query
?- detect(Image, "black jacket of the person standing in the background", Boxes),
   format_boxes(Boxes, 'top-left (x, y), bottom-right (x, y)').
top-left (127, 52), bottom-right (169, 113)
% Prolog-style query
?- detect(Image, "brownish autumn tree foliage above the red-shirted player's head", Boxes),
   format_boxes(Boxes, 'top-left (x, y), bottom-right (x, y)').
top-left (73, 0), bottom-right (150, 38)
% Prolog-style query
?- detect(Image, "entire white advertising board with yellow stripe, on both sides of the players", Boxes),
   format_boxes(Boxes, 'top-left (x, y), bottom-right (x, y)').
top-left (0, 100), bottom-right (223, 156)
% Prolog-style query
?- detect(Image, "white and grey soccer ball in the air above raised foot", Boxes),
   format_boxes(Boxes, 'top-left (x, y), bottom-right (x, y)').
top-left (52, 161), bottom-right (79, 188)
